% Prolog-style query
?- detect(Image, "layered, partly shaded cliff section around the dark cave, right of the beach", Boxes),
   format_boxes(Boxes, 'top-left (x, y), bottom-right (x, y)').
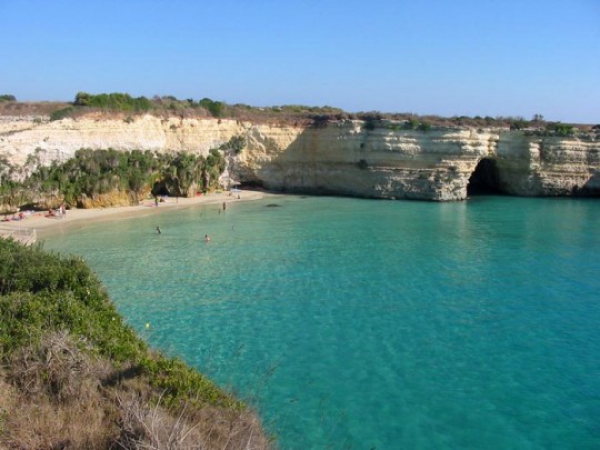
top-left (236, 121), bottom-right (600, 201)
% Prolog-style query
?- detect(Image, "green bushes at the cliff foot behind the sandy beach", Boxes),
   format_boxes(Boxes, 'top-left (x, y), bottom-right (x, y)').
top-left (5, 148), bottom-right (230, 207)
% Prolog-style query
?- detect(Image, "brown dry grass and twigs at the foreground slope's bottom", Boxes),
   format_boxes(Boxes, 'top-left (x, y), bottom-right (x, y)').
top-left (0, 332), bottom-right (271, 450)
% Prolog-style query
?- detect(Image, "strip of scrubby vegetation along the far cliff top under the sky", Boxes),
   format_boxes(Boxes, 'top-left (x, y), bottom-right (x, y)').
top-left (0, 92), bottom-right (591, 131)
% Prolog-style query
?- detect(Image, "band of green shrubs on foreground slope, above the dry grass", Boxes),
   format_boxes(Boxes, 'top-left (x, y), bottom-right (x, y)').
top-left (0, 239), bottom-right (243, 409)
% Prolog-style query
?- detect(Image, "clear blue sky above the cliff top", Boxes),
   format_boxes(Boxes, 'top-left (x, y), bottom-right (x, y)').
top-left (0, 0), bottom-right (600, 124)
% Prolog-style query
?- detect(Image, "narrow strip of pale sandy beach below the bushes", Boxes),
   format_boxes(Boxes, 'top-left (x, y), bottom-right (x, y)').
top-left (0, 191), bottom-right (278, 240)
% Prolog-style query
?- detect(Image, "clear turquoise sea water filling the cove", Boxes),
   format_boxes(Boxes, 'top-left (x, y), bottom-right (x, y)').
top-left (45, 196), bottom-right (600, 450)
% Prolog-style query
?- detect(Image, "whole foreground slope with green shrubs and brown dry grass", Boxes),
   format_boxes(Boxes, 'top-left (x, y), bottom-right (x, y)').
top-left (0, 239), bottom-right (268, 449)
